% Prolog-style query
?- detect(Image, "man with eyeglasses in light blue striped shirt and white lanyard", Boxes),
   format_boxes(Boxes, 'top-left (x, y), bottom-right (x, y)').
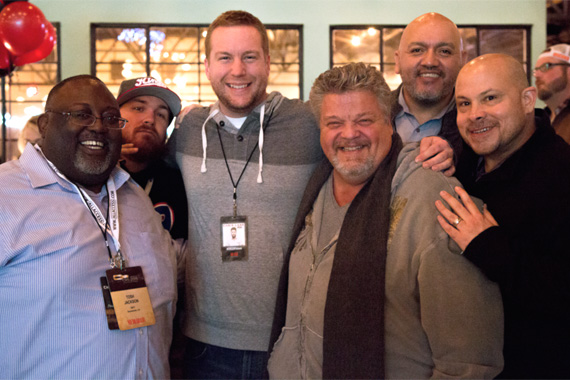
top-left (0, 75), bottom-right (176, 379)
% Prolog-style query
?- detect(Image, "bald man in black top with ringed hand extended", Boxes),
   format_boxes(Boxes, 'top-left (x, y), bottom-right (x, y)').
top-left (436, 54), bottom-right (570, 378)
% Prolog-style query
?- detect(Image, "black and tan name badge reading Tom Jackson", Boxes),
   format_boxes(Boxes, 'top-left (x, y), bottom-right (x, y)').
top-left (106, 267), bottom-right (155, 330)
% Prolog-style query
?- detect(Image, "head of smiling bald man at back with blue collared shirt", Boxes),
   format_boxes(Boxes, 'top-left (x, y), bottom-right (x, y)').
top-left (394, 13), bottom-right (465, 107)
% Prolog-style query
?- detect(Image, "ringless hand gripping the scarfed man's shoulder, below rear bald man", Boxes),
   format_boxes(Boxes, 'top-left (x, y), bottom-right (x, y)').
top-left (416, 136), bottom-right (455, 177)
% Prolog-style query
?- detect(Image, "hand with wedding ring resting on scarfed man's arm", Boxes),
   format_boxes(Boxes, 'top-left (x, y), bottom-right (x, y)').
top-left (435, 186), bottom-right (499, 250)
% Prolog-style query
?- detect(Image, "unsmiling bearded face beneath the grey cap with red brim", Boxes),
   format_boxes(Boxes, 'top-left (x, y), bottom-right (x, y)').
top-left (121, 95), bottom-right (170, 162)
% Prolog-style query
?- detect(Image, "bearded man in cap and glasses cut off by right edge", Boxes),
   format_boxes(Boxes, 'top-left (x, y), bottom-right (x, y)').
top-left (533, 44), bottom-right (570, 143)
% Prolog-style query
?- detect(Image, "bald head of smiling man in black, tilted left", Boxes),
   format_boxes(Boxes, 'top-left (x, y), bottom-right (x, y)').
top-left (455, 54), bottom-right (536, 172)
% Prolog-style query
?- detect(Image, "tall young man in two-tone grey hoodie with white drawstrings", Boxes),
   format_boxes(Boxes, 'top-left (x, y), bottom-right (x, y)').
top-left (169, 11), bottom-right (322, 379)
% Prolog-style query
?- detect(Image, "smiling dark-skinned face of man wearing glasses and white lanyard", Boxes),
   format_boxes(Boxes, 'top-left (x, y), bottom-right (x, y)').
top-left (38, 77), bottom-right (121, 191)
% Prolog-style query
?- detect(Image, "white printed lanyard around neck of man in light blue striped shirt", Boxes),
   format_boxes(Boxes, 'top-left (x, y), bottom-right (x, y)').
top-left (36, 146), bottom-right (126, 269)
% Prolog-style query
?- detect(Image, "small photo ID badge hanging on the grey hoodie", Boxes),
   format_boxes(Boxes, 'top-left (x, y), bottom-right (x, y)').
top-left (220, 216), bottom-right (247, 261)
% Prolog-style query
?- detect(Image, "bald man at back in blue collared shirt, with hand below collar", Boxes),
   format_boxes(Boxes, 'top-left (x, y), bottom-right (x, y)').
top-left (392, 13), bottom-right (466, 175)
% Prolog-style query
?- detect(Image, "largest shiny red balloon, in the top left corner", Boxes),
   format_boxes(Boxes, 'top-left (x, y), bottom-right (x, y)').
top-left (0, 1), bottom-right (48, 56)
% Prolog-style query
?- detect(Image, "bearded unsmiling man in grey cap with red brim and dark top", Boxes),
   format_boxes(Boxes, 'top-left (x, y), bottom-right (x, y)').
top-left (117, 77), bottom-right (188, 240)
